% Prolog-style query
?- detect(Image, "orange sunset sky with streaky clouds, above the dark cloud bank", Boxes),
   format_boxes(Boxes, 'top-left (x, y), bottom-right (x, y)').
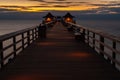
top-left (0, 0), bottom-right (120, 14)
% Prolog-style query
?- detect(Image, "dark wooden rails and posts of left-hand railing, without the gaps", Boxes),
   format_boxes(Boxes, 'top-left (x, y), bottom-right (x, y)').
top-left (0, 27), bottom-right (38, 68)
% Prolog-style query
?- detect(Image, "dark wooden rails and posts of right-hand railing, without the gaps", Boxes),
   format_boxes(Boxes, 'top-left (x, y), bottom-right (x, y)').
top-left (65, 22), bottom-right (120, 69)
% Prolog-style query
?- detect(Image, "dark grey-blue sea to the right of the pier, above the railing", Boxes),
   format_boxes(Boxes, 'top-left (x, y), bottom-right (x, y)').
top-left (76, 20), bottom-right (120, 37)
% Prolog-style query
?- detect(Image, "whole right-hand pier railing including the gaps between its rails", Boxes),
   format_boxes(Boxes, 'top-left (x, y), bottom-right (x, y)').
top-left (64, 23), bottom-right (120, 70)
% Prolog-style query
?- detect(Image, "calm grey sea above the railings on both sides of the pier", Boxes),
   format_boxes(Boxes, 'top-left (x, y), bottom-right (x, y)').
top-left (0, 20), bottom-right (120, 37)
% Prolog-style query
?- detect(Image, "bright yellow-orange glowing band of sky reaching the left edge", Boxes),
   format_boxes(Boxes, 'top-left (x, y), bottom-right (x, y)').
top-left (1, 6), bottom-right (99, 12)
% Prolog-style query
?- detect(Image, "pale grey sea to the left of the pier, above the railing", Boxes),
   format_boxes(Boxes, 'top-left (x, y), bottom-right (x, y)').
top-left (0, 20), bottom-right (41, 35)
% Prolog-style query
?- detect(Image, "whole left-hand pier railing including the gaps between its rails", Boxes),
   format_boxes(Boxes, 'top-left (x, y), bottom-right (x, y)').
top-left (0, 22), bottom-right (53, 68)
